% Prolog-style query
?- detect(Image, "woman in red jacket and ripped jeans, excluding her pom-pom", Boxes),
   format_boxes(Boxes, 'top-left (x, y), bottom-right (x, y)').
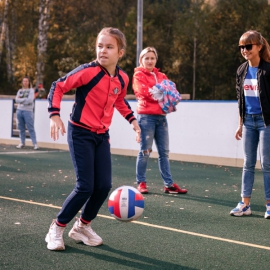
top-left (132, 47), bottom-right (187, 194)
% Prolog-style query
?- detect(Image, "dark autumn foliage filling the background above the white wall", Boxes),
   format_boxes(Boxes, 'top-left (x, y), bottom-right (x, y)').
top-left (0, 0), bottom-right (270, 100)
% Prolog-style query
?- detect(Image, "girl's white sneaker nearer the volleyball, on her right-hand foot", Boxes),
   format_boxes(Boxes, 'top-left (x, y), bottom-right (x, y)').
top-left (68, 218), bottom-right (103, 246)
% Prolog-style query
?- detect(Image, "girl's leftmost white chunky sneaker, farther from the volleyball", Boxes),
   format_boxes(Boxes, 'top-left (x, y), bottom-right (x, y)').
top-left (45, 219), bottom-right (65, 250)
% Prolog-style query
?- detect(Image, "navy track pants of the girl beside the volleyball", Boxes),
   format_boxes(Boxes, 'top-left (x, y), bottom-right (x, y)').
top-left (57, 122), bottom-right (112, 224)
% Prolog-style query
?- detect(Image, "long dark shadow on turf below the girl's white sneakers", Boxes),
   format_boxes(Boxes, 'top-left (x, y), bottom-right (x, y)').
top-left (62, 243), bottom-right (196, 270)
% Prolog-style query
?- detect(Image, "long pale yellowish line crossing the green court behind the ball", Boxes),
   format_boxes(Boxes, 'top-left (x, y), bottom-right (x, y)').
top-left (0, 196), bottom-right (270, 250)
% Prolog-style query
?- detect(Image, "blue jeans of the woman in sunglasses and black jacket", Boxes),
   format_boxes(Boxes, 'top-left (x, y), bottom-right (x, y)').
top-left (241, 114), bottom-right (270, 200)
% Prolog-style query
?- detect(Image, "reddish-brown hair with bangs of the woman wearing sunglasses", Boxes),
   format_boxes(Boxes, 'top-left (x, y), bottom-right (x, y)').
top-left (239, 30), bottom-right (270, 62)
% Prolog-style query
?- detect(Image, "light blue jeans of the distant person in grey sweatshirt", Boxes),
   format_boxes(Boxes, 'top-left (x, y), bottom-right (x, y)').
top-left (17, 110), bottom-right (37, 145)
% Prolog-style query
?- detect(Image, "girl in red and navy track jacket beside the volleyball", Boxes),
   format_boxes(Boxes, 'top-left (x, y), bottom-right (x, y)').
top-left (45, 27), bottom-right (140, 250)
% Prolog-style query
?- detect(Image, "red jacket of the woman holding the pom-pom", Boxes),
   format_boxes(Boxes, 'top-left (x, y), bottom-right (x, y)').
top-left (132, 67), bottom-right (168, 114)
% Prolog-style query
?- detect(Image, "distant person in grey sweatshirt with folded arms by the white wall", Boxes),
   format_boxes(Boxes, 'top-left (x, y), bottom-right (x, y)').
top-left (15, 77), bottom-right (39, 150)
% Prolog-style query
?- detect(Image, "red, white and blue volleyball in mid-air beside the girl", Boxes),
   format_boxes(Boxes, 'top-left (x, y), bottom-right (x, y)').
top-left (108, 186), bottom-right (144, 222)
